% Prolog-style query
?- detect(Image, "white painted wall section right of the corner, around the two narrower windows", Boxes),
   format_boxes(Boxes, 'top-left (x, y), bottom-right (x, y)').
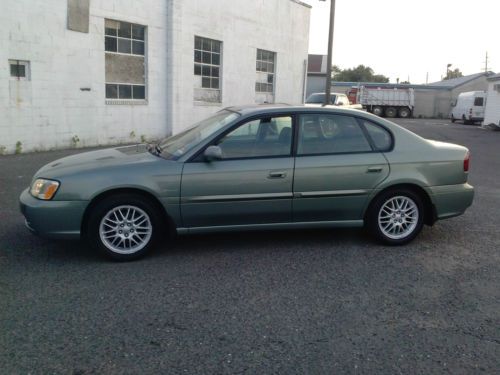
top-left (169, 0), bottom-right (310, 133)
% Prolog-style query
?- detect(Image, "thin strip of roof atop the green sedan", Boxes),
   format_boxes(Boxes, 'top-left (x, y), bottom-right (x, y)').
top-left (225, 104), bottom-right (366, 116)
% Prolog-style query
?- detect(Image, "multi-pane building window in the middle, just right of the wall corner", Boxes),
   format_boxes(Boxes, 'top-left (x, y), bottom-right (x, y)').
top-left (194, 36), bottom-right (222, 102)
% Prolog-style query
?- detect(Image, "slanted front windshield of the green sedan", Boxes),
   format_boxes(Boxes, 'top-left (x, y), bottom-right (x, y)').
top-left (158, 110), bottom-right (239, 160)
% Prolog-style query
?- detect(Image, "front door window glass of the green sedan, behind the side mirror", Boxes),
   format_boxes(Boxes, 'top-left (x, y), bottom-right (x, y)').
top-left (218, 116), bottom-right (292, 159)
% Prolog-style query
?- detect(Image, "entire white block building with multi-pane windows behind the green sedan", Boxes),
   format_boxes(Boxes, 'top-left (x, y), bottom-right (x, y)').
top-left (0, 0), bottom-right (310, 153)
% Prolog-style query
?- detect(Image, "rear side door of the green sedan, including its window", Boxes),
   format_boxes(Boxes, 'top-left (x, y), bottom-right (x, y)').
top-left (293, 114), bottom-right (392, 222)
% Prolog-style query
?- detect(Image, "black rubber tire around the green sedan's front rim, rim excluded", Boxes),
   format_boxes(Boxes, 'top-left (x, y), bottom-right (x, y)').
top-left (87, 194), bottom-right (161, 261)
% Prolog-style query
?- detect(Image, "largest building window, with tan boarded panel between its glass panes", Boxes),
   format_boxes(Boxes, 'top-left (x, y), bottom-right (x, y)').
top-left (104, 20), bottom-right (146, 104)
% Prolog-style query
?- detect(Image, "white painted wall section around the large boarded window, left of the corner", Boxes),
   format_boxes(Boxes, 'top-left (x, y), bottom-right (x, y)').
top-left (0, 0), bottom-right (168, 152)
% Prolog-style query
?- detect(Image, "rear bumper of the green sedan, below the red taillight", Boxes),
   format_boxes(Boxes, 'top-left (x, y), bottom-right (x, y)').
top-left (429, 183), bottom-right (474, 220)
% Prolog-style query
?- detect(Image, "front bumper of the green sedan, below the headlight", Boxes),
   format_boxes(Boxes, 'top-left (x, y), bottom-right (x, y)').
top-left (19, 189), bottom-right (88, 239)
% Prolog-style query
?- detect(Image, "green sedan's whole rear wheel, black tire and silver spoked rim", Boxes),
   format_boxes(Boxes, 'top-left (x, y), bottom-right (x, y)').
top-left (365, 189), bottom-right (425, 246)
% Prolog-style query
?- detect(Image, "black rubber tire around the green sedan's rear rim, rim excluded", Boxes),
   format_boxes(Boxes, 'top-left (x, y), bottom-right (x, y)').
top-left (367, 189), bottom-right (425, 246)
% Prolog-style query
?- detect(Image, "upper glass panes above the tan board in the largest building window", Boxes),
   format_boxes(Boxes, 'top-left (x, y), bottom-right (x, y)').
top-left (104, 20), bottom-right (146, 56)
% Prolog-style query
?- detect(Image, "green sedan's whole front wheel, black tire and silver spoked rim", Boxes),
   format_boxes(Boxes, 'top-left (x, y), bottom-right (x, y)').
top-left (87, 194), bottom-right (162, 261)
